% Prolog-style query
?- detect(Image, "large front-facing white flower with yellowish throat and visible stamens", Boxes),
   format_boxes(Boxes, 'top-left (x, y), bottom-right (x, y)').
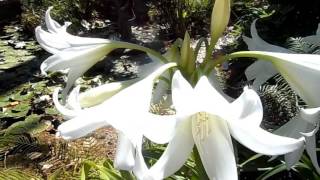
top-left (145, 71), bottom-right (304, 180)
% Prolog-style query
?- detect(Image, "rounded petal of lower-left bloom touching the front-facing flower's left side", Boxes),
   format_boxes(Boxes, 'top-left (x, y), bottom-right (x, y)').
top-left (143, 113), bottom-right (176, 144)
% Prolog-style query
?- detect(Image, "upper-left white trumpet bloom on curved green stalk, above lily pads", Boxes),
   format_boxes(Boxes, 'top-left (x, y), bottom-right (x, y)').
top-left (35, 7), bottom-right (164, 97)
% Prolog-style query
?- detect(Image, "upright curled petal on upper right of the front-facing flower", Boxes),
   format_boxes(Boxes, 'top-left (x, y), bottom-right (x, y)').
top-left (228, 87), bottom-right (263, 127)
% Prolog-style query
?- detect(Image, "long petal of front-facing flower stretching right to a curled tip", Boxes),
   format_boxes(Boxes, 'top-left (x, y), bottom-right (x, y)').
top-left (228, 120), bottom-right (304, 155)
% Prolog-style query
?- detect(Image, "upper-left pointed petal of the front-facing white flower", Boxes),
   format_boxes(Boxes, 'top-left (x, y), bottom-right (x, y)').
top-left (172, 71), bottom-right (196, 116)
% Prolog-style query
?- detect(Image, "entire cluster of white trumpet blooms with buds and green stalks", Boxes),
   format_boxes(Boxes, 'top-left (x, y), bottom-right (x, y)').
top-left (36, 0), bottom-right (320, 180)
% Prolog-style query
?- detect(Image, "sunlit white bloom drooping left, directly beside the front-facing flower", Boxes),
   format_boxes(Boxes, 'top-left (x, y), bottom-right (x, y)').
top-left (53, 63), bottom-right (176, 177)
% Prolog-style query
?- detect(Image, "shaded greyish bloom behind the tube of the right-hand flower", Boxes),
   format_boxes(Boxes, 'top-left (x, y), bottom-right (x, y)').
top-left (242, 20), bottom-right (294, 90)
